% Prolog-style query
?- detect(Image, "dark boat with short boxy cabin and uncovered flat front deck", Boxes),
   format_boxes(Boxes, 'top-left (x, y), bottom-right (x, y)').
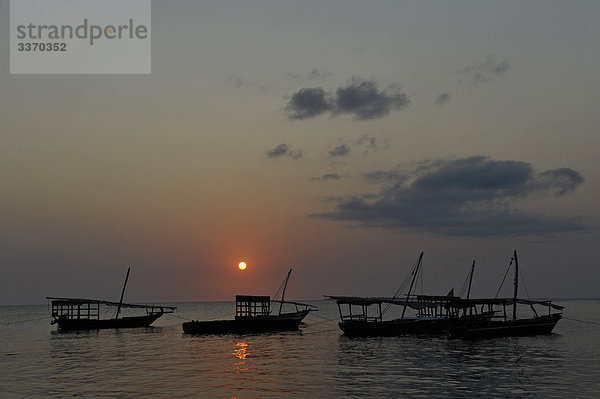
top-left (182, 269), bottom-right (316, 334)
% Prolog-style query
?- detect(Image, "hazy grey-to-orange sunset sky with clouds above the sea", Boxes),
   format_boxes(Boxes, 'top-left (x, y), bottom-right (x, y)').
top-left (0, 0), bottom-right (600, 305)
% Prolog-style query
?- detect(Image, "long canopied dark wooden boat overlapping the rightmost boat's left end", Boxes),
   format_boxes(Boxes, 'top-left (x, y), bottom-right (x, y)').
top-left (326, 252), bottom-right (490, 337)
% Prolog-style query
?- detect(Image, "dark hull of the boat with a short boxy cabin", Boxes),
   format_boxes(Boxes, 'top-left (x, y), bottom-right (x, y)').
top-left (182, 310), bottom-right (310, 334)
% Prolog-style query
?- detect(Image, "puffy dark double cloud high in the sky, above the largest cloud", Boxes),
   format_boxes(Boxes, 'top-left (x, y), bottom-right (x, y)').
top-left (285, 78), bottom-right (410, 120)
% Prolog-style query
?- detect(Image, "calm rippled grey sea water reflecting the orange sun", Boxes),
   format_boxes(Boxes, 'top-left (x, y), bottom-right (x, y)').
top-left (0, 300), bottom-right (600, 398)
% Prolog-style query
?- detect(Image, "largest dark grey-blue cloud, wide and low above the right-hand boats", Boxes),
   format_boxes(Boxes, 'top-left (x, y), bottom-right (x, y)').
top-left (311, 156), bottom-right (587, 236)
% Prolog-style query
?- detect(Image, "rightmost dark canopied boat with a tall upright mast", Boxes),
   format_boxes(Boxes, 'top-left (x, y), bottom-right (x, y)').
top-left (449, 250), bottom-right (564, 338)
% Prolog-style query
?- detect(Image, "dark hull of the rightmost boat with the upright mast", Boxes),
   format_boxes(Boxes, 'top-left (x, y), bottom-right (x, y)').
top-left (449, 314), bottom-right (562, 338)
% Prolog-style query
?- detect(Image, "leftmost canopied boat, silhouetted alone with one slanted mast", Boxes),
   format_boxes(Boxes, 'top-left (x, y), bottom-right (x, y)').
top-left (46, 269), bottom-right (177, 331)
